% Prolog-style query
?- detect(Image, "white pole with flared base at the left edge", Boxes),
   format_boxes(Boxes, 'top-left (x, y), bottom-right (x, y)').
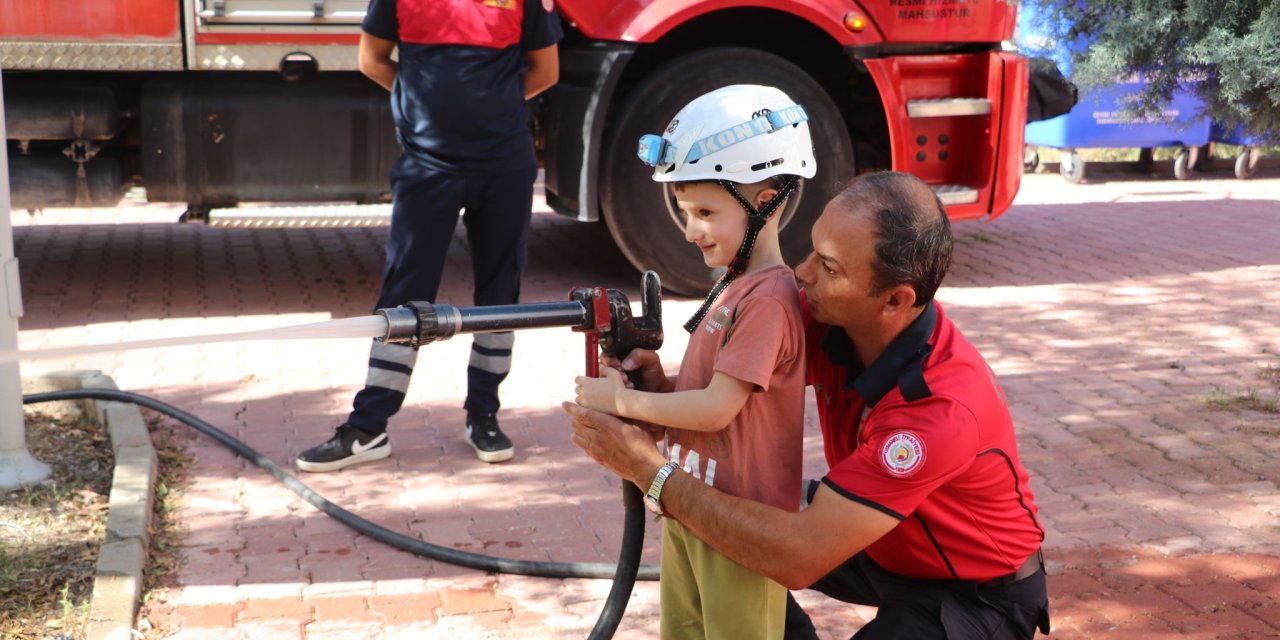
top-left (0, 62), bottom-right (51, 490)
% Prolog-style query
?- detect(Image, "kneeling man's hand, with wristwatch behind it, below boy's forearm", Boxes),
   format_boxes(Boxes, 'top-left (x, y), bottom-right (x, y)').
top-left (562, 402), bottom-right (667, 492)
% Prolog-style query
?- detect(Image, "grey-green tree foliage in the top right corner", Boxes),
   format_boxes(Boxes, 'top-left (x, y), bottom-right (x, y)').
top-left (1023, 0), bottom-right (1280, 134)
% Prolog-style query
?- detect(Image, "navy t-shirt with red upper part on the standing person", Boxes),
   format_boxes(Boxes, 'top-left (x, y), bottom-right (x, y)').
top-left (364, 0), bottom-right (563, 174)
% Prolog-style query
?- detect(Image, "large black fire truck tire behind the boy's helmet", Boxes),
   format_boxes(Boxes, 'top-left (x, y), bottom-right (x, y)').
top-left (600, 47), bottom-right (854, 296)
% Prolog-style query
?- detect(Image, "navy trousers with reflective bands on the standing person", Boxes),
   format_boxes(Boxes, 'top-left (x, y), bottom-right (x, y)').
top-left (347, 155), bottom-right (538, 434)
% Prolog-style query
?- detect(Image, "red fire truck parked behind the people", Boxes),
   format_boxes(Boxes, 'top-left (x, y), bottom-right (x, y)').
top-left (0, 0), bottom-right (1028, 293)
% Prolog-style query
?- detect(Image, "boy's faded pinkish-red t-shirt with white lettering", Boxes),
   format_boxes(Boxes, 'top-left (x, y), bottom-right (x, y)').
top-left (667, 265), bottom-right (805, 511)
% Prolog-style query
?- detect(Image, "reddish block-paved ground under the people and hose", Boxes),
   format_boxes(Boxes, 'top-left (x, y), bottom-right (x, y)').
top-left (12, 167), bottom-right (1280, 640)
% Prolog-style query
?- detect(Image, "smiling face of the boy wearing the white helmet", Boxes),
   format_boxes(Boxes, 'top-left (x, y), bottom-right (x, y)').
top-left (673, 183), bottom-right (746, 269)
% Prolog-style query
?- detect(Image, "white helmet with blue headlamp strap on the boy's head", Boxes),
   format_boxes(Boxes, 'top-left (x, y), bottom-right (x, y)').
top-left (637, 84), bottom-right (818, 184)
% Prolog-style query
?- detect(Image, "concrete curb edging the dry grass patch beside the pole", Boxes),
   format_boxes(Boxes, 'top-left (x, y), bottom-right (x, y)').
top-left (23, 371), bottom-right (157, 640)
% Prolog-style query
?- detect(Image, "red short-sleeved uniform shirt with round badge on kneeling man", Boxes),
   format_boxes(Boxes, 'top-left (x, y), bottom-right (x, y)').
top-left (805, 302), bottom-right (1044, 581)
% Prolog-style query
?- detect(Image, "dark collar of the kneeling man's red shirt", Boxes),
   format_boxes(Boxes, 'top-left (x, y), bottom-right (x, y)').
top-left (822, 301), bottom-right (938, 407)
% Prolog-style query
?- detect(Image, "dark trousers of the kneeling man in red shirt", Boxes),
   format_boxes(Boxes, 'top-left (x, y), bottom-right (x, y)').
top-left (785, 553), bottom-right (1048, 640)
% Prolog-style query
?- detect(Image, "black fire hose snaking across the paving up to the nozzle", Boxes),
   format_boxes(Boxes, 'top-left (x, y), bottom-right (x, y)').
top-left (22, 389), bottom-right (658, 640)
